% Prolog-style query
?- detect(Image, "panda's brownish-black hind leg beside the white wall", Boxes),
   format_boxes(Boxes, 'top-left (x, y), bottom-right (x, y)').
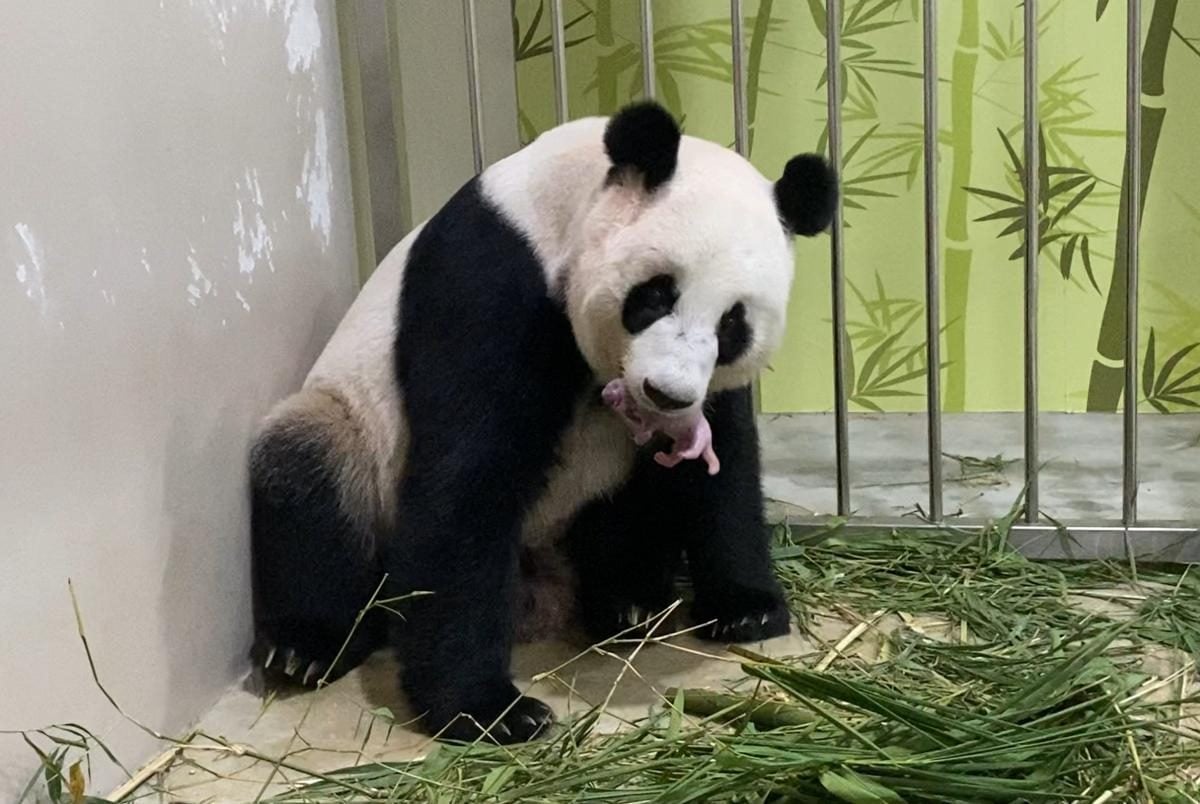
top-left (250, 390), bottom-right (386, 688)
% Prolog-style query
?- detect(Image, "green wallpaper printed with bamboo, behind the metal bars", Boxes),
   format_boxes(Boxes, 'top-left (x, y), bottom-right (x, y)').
top-left (514, 0), bottom-right (1200, 413)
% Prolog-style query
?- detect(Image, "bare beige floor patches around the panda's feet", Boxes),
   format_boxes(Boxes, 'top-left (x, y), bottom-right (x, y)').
top-left (150, 619), bottom-right (825, 804)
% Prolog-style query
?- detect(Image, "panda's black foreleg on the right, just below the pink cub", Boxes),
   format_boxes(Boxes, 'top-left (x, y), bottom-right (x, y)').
top-left (647, 386), bottom-right (791, 642)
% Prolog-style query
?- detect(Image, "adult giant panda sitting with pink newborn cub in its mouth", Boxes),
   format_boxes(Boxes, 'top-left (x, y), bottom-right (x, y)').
top-left (251, 103), bottom-right (836, 743)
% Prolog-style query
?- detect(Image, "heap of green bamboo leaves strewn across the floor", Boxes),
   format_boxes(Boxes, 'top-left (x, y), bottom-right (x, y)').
top-left (258, 524), bottom-right (1200, 804)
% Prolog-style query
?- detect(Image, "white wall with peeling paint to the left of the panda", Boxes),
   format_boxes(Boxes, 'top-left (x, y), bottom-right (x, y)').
top-left (0, 0), bottom-right (356, 800)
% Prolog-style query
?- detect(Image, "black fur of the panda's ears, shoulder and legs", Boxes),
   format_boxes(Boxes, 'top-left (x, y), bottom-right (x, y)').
top-left (251, 104), bottom-right (833, 742)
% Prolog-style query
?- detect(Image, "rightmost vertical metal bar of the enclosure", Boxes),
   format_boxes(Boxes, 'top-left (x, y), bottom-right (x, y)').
top-left (1121, 0), bottom-right (1141, 526)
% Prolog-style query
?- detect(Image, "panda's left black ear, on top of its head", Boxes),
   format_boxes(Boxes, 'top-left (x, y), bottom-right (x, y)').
top-left (604, 101), bottom-right (680, 192)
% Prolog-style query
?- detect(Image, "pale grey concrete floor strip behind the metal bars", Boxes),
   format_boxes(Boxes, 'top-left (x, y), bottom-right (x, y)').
top-left (761, 413), bottom-right (1200, 526)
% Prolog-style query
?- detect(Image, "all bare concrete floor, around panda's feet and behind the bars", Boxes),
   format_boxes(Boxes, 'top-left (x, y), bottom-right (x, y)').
top-left (131, 414), bottom-right (1200, 804)
